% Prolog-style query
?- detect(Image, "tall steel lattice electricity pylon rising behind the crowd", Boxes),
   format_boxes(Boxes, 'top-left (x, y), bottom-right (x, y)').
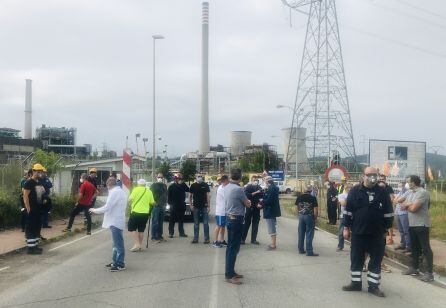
top-left (282, 0), bottom-right (356, 171)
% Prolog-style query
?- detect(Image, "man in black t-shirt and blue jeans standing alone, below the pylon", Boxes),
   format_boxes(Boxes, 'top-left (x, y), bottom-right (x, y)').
top-left (295, 185), bottom-right (318, 257)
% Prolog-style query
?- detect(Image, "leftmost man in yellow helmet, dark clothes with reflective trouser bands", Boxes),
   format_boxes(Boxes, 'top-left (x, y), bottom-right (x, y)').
top-left (23, 164), bottom-right (44, 254)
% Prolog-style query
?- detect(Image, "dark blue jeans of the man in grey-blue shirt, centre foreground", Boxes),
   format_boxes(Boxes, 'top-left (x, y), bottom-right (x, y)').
top-left (225, 216), bottom-right (244, 279)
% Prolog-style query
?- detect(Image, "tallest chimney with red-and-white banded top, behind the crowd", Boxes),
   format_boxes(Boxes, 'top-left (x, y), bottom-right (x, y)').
top-left (199, 2), bottom-right (210, 153)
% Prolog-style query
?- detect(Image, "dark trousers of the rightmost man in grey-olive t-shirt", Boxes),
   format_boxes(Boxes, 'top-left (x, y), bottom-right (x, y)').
top-left (409, 227), bottom-right (434, 274)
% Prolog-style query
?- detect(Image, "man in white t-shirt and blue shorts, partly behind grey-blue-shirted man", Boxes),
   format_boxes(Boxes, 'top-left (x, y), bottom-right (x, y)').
top-left (212, 175), bottom-right (229, 248)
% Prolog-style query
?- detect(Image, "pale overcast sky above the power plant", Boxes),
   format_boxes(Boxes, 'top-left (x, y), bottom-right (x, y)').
top-left (0, 0), bottom-right (446, 156)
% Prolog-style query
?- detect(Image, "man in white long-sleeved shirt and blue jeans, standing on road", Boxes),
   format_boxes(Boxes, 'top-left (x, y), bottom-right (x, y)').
top-left (90, 178), bottom-right (127, 272)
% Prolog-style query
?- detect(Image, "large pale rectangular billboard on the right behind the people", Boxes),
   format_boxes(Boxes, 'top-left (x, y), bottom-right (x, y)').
top-left (369, 139), bottom-right (426, 184)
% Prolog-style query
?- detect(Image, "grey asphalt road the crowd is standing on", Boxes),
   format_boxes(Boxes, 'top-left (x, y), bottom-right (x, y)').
top-left (0, 208), bottom-right (446, 308)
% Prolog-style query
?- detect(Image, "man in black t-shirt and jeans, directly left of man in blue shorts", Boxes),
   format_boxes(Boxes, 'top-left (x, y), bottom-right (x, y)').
top-left (189, 174), bottom-right (211, 244)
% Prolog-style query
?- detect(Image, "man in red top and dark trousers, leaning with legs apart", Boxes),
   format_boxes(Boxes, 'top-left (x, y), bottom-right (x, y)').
top-left (63, 173), bottom-right (97, 235)
